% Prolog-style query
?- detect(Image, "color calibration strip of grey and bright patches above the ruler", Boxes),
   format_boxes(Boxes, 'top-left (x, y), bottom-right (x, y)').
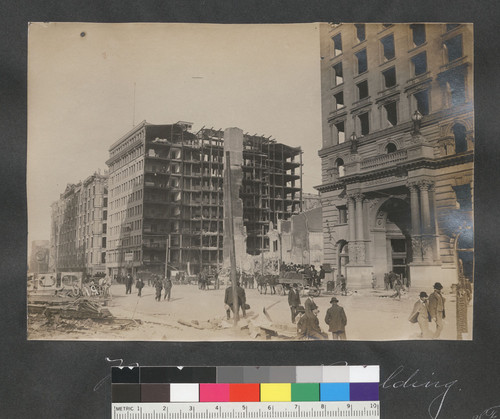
top-left (111, 365), bottom-right (380, 404)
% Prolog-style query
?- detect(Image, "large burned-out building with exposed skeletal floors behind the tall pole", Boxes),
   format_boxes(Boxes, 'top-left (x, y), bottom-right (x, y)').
top-left (106, 121), bottom-right (302, 275)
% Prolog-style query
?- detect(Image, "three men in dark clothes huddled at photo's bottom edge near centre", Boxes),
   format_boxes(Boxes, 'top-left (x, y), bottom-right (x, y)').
top-left (288, 284), bottom-right (347, 340)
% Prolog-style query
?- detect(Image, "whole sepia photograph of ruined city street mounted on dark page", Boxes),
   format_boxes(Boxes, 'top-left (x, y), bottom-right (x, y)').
top-left (26, 23), bottom-right (474, 341)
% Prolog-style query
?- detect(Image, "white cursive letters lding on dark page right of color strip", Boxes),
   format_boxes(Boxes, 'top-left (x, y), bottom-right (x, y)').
top-left (381, 365), bottom-right (458, 419)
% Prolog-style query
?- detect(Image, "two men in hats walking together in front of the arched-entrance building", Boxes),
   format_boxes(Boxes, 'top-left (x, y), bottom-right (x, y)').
top-left (409, 282), bottom-right (446, 339)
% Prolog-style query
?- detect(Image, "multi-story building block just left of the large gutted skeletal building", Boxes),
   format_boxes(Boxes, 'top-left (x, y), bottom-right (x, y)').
top-left (50, 173), bottom-right (108, 275)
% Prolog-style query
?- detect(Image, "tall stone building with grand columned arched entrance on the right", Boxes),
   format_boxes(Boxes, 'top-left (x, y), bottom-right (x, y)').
top-left (317, 24), bottom-right (474, 286)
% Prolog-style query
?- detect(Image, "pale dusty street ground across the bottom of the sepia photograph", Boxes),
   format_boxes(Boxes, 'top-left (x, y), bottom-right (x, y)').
top-left (30, 284), bottom-right (472, 341)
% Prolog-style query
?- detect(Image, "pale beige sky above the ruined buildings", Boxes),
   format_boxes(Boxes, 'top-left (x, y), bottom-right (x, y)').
top-left (27, 23), bottom-right (321, 242)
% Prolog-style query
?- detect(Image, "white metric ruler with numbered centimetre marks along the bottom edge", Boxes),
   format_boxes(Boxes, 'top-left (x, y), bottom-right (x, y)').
top-left (112, 401), bottom-right (380, 419)
